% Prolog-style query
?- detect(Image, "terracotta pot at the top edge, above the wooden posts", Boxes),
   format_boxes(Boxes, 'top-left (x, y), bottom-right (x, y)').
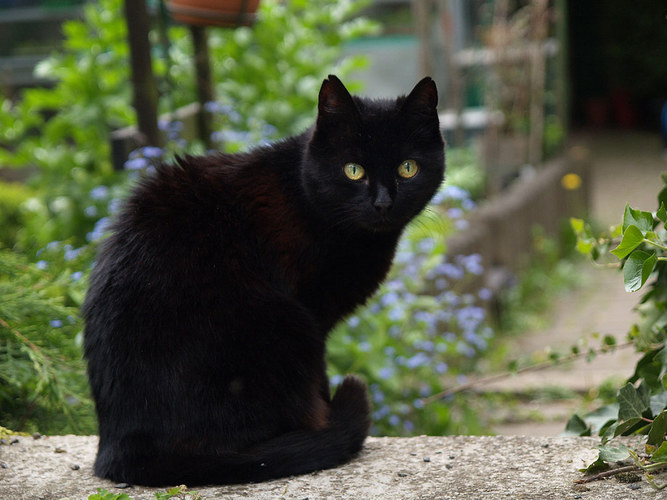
top-left (167, 0), bottom-right (260, 27)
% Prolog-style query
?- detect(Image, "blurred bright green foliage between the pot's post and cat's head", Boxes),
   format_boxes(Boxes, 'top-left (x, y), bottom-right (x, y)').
top-left (198, 0), bottom-right (378, 137)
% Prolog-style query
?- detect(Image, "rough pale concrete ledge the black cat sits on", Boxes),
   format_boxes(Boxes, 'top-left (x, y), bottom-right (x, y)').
top-left (0, 436), bottom-right (667, 500)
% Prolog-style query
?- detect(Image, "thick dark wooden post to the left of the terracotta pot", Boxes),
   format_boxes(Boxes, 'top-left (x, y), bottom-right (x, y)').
top-left (125, 0), bottom-right (161, 146)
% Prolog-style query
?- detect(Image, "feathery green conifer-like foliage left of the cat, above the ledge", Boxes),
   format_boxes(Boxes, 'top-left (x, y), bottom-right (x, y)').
top-left (0, 248), bottom-right (94, 433)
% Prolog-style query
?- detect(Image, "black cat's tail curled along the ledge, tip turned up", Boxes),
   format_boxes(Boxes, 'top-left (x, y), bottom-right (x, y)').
top-left (95, 376), bottom-right (370, 486)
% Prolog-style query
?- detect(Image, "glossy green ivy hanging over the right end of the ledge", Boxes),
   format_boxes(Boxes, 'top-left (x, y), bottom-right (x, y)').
top-left (567, 174), bottom-right (667, 487)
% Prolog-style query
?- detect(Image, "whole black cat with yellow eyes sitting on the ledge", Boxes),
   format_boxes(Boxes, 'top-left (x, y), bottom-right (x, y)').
top-left (83, 76), bottom-right (444, 485)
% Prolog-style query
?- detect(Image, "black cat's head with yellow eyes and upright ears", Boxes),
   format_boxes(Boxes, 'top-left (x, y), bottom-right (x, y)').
top-left (302, 75), bottom-right (445, 232)
